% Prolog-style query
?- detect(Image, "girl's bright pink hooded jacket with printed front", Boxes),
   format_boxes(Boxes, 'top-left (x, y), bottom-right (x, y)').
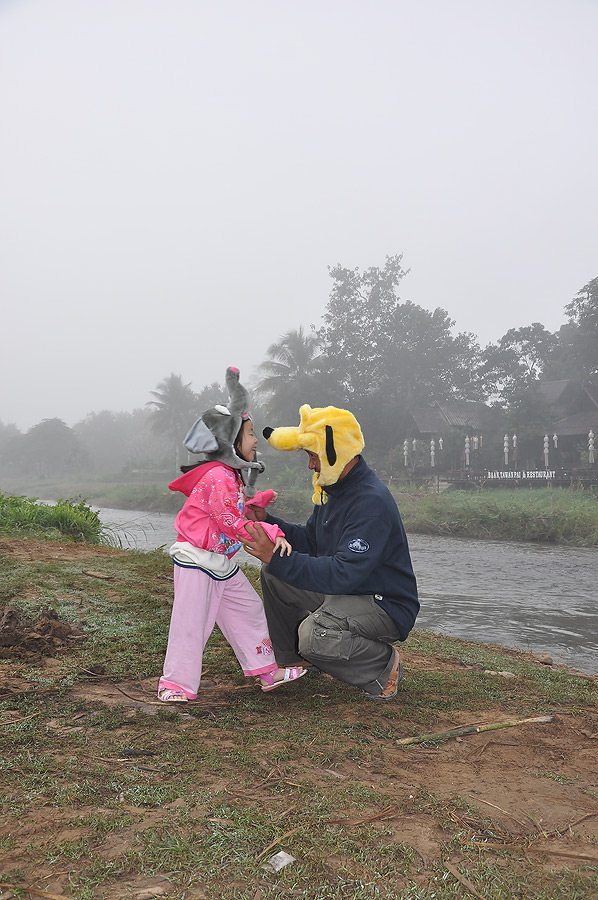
top-left (168, 462), bottom-right (284, 557)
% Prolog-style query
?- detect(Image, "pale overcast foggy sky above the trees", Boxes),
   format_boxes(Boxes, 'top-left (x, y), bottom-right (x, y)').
top-left (0, 0), bottom-right (598, 429)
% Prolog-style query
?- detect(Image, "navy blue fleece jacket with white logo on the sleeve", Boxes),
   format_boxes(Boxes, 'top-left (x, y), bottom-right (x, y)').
top-left (266, 456), bottom-right (419, 640)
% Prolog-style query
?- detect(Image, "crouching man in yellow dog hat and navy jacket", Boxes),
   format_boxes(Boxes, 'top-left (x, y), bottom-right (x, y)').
top-left (244, 405), bottom-right (419, 700)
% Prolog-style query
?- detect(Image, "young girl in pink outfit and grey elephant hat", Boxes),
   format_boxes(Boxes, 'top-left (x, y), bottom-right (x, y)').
top-left (158, 368), bottom-right (306, 702)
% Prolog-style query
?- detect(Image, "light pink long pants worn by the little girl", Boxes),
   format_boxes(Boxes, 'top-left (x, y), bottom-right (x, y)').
top-left (159, 565), bottom-right (278, 700)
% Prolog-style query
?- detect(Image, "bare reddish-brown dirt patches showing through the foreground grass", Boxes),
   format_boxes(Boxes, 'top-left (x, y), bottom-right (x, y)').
top-left (0, 541), bottom-right (598, 900)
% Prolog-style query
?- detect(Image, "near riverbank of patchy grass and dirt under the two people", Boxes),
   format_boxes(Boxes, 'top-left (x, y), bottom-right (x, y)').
top-left (0, 533), bottom-right (598, 900)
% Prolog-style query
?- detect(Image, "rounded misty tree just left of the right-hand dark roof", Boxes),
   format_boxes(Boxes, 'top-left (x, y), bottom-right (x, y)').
top-left (478, 322), bottom-right (558, 405)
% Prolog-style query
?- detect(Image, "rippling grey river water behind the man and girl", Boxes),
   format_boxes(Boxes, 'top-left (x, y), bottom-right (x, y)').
top-left (99, 509), bottom-right (598, 673)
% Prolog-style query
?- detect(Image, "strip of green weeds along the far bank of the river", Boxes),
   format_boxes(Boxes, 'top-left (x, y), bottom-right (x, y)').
top-left (0, 481), bottom-right (598, 547)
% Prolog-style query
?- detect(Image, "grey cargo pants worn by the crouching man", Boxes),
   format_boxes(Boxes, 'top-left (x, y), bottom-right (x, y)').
top-left (261, 565), bottom-right (399, 696)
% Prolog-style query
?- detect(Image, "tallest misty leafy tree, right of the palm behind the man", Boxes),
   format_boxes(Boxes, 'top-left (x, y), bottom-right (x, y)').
top-left (320, 255), bottom-right (481, 448)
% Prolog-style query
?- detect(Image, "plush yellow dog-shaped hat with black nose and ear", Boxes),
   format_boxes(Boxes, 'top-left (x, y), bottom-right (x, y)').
top-left (263, 403), bottom-right (365, 506)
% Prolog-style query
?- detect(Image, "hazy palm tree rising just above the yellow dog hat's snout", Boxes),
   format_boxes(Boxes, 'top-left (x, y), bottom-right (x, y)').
top-left (256, 326), bottom-right (324, 423)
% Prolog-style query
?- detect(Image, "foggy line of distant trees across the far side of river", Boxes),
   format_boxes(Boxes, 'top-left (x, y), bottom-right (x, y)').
top-left (0, 255), bottom-right (598, 478)
